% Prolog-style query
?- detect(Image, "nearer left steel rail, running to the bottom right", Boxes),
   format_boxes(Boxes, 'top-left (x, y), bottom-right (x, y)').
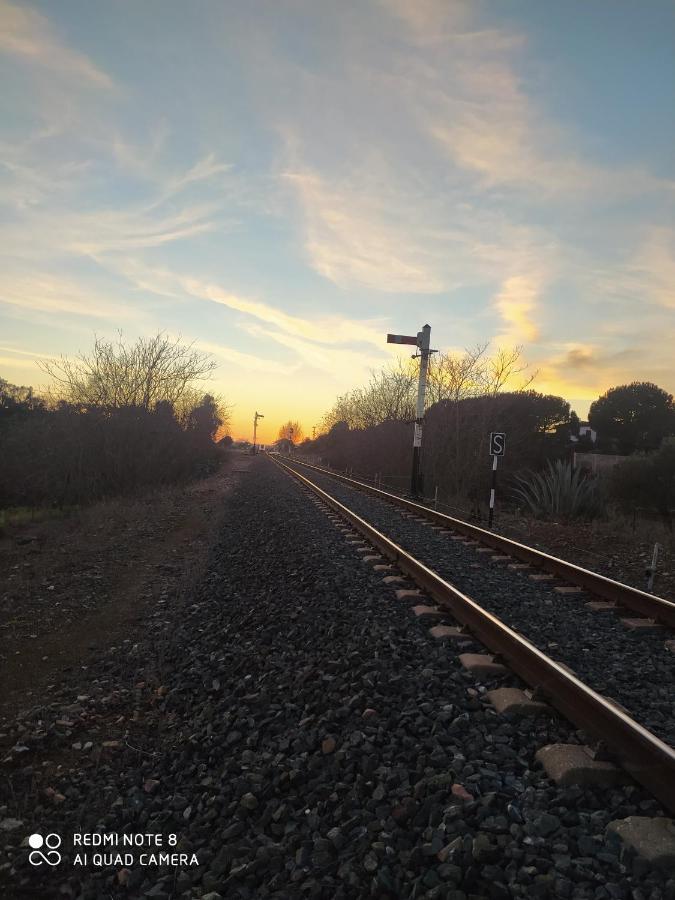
top-left (272, 457), bottom-right (675, 813)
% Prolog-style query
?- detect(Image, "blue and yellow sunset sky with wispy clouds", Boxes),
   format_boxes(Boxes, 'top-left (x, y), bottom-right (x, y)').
top-left (0, 0), bottom-right (675, 442)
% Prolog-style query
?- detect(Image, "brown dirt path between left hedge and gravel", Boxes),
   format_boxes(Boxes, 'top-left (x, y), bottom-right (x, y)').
top-left (0, 454), bottom-right (250, 728)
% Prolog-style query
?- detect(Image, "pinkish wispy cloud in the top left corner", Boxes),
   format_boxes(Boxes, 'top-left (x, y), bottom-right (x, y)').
top-left (0, 0), bottom-right (114, 90)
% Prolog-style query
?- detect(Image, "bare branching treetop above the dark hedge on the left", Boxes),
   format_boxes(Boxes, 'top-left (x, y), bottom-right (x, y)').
top-left (39, 332), bottom-right (216, 416)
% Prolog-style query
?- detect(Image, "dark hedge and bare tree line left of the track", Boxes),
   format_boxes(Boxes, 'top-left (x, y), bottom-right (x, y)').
top-left (0, 333), bottom-right (229, 508)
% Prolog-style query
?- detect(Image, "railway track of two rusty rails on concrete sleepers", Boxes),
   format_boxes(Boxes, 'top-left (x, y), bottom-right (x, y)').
top-left (275, 458), bottom-right (675, 812)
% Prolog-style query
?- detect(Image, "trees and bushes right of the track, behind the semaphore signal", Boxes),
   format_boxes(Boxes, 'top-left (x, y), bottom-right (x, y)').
top-left (301, 345), bottom-right (675, 515)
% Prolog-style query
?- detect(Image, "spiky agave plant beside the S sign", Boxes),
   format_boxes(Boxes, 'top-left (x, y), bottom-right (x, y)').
top-left (512, 460), bottom-right (605, 519)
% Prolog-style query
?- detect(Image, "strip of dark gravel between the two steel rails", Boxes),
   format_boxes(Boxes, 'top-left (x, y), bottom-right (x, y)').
top-left (290, 467), bottom-right (675, 746)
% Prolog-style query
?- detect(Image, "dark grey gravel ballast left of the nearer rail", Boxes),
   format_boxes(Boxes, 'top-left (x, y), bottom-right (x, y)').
top-left (0, 458), bottom-right (675, 900)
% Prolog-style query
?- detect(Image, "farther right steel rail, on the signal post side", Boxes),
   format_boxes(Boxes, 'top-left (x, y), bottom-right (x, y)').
top-left (282, 459), bottom-right (675, 628)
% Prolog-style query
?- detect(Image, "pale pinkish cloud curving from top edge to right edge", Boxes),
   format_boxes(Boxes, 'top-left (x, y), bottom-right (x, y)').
top-left (381, 0), bottom-right (675, 203)
